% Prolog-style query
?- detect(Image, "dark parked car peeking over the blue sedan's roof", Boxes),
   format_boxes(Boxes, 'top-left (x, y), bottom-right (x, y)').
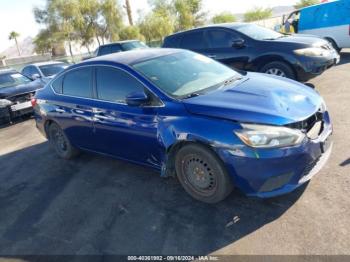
top-left (95, 40), bottom-right (148, 56)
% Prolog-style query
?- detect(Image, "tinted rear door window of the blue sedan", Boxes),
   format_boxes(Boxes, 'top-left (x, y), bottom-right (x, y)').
top-left (63, 67), bottom-right (92, 98)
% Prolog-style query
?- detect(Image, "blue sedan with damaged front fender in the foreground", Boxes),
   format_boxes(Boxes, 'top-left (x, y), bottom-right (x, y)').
top-left (32, 49), bottom-right (332, 203)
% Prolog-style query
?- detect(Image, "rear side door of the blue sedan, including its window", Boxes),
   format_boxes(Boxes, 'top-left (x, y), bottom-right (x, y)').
top-left (51, 67), bottom-right (94, 149)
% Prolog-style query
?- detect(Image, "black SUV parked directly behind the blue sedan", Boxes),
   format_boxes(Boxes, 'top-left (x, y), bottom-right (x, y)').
top-left (163, 23), bottom-right (340, 82)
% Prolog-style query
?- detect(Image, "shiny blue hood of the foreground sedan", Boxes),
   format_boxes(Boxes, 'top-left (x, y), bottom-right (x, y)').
top-left (183, 73), bottom-right (323, 125)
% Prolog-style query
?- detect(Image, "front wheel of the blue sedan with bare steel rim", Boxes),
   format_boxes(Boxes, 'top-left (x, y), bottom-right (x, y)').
top-left (175, 144), bottom-right (233, 204)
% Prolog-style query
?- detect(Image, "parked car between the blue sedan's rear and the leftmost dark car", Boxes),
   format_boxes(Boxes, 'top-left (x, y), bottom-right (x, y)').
top-left (22, 61), bottom-right (69, 84)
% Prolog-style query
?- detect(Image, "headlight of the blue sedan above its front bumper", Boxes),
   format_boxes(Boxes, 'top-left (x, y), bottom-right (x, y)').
top-left (234, 124), bottom-right (305, 148)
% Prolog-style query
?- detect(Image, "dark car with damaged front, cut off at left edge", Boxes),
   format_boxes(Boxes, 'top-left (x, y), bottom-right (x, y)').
top-left (0, 69), bottom-right (43, 124)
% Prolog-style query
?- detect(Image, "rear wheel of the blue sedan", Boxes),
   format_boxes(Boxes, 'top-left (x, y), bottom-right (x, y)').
top-left (48, 123), bottom-right (79, 159)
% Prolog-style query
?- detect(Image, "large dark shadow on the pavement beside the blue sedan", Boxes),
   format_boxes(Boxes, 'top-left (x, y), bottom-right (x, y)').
top-left (0, 143), bottom-right (305, 255)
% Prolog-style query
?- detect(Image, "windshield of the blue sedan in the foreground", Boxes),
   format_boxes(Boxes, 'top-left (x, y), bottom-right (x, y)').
top-left (133, 51), bottom-right (241, 98)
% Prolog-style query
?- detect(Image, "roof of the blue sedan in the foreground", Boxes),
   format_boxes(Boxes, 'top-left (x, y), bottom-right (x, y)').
top-left (77, 48), bottom-right (182, 66)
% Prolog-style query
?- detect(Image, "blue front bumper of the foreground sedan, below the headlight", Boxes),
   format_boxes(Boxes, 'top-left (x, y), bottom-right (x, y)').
top-left (218, 113), bottom-right (333, 198)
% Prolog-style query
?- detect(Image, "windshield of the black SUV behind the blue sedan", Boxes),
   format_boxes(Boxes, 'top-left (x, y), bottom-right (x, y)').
top-left (235, 24), bottom-right (285, 40)
